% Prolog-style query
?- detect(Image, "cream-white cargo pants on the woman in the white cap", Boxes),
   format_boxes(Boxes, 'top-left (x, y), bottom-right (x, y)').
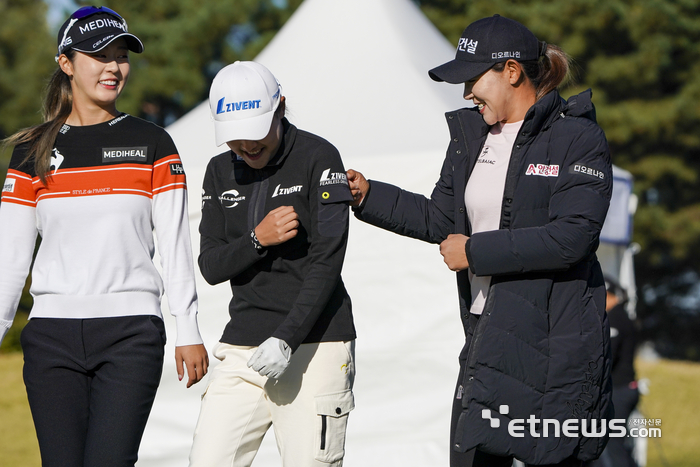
top-left (190, 341), bottom-right (355, 467)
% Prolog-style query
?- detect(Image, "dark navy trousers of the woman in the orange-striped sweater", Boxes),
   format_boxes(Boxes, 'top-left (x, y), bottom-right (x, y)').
top-left (21, 316), bottom-right (165, 467)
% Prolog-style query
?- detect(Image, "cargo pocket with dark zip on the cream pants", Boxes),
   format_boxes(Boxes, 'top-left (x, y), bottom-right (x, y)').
top-left (315, 389), bottom-right (355, 463)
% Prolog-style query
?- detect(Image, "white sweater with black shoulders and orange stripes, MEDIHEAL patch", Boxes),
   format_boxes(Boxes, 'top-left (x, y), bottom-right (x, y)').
top-left (0, 114), bottom-right (202, 346)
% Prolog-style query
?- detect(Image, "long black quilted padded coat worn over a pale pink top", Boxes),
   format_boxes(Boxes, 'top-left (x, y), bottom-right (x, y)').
top-left (356, 91), bottom-right (612, 464)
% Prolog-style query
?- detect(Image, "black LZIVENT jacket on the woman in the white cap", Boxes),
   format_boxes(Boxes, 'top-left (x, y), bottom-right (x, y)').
top-left (199, 119), bottom-right (355, 351)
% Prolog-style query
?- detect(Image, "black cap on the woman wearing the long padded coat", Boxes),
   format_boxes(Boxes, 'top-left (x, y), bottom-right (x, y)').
top-left (428, 15), bottom-right (545, 84)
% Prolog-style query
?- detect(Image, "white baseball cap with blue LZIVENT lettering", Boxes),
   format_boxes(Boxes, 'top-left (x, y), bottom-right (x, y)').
top-left (209, 62), bottom-right (282, 146)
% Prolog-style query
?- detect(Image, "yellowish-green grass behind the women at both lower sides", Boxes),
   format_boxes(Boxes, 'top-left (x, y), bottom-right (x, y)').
top-left (0, 353), bottom-right (700, 467)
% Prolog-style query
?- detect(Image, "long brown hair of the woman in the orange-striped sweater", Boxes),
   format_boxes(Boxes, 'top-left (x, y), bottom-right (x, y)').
top-left (3, 49), bottom-right (75, 185)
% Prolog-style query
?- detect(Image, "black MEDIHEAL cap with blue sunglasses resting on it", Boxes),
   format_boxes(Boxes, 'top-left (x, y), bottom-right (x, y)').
top-left (56, 6), bottom-right (143, 60)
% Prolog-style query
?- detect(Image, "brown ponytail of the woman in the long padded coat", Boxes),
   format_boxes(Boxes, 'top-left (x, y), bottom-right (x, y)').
top-left (493, 42), bottom-right (571, 100)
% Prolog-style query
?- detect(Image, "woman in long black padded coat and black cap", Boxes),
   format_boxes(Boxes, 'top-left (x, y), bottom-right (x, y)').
top-left (348, 15), bottom-right (612, 467)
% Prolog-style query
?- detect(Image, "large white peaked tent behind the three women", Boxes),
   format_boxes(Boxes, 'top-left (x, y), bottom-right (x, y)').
top-left (137, 0), bottom-right (636, 467)
